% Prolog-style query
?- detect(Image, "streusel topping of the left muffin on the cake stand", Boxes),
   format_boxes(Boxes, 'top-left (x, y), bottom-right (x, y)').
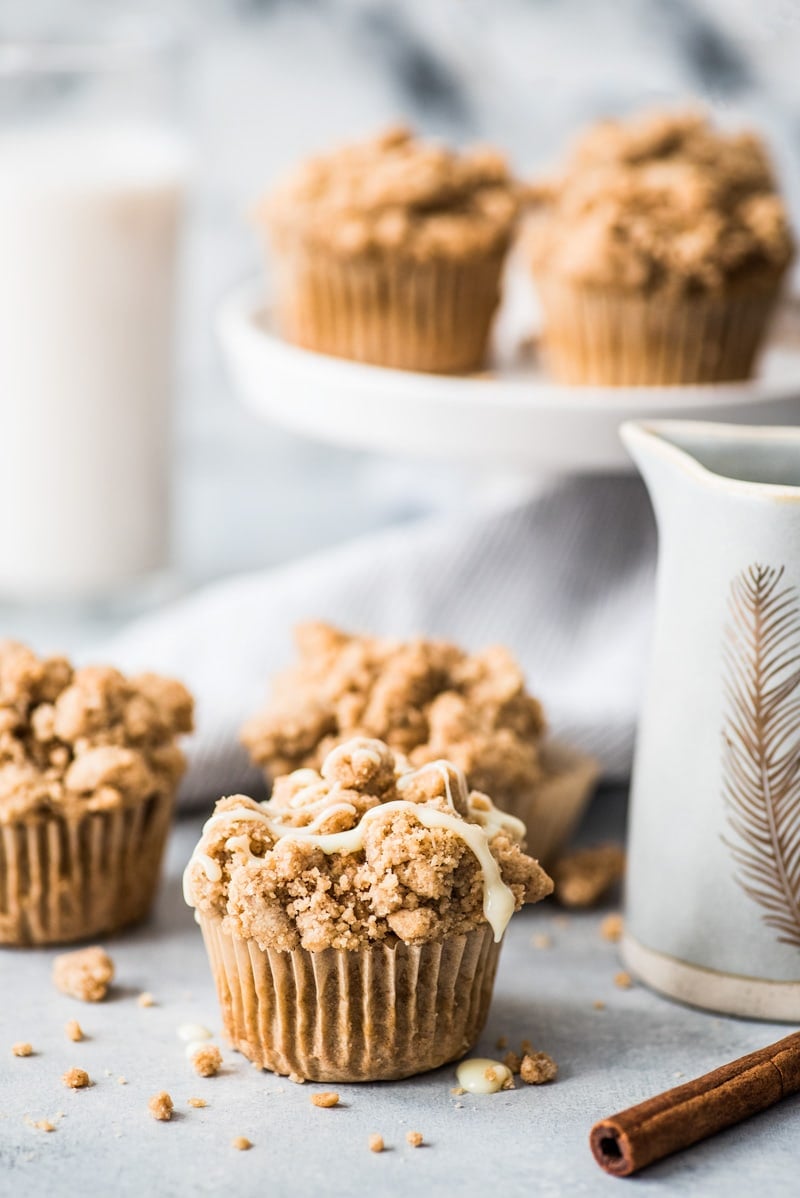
top-left (257, 127), bottom-right (522, 259)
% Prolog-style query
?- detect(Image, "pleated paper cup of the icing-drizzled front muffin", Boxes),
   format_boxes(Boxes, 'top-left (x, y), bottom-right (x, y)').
top-left (200, 914), bottom-right (501, 1082)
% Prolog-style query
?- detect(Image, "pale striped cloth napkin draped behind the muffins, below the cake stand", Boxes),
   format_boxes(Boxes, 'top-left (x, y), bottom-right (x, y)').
top-left (104, 477), bottom-right (655, 805)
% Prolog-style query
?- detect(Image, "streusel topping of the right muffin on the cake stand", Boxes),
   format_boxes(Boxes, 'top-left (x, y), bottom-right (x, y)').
top-left (527, 111), bottom-right (793, 292)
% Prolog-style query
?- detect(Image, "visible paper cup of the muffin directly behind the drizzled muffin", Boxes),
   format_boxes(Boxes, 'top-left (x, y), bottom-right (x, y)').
top-left (503, 740), bottom-right (600, 869)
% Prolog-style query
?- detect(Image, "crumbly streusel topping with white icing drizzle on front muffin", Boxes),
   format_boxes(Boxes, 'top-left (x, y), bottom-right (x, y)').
top-left (184, 738), bottom-right (552, 951)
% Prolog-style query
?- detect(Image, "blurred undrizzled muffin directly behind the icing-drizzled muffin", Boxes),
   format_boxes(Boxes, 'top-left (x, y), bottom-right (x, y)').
top-left (242, 623), bottom-right (598, 865)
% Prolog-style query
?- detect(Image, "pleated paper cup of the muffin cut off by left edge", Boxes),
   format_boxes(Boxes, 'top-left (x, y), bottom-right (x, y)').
top-left (0, 795), bottom-right (172, 946)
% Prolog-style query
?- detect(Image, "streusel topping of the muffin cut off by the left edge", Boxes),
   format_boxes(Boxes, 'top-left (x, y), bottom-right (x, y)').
top-left (0, 641), bottom-right (193, 823)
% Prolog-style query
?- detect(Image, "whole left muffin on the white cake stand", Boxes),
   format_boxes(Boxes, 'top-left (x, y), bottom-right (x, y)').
top-left (256, 128), bottom-right (521, 371)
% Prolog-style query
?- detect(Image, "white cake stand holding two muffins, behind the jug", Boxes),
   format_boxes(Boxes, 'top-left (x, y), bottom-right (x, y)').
top-left (218, 282), bottom-right (800, 473)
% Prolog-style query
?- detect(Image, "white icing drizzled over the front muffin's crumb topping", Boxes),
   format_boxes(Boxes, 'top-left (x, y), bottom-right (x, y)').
top-left (183, 740), bottom-right (525, 942)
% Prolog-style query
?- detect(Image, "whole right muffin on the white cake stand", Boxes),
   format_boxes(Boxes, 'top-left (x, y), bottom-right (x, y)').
top-left (525, 111), bottom-right (793, 386)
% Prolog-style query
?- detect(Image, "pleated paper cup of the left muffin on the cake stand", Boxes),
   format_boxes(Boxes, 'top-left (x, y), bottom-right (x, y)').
top-left (268, 246), bottom-right (504, 374)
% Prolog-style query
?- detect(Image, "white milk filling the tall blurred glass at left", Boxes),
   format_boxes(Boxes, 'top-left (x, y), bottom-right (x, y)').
top-left (0, 127), bottom-right (183, 599)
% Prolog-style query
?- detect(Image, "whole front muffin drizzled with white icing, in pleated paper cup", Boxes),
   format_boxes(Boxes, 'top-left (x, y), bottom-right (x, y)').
top-left (184, 738), bottom-right (552, 1082)
